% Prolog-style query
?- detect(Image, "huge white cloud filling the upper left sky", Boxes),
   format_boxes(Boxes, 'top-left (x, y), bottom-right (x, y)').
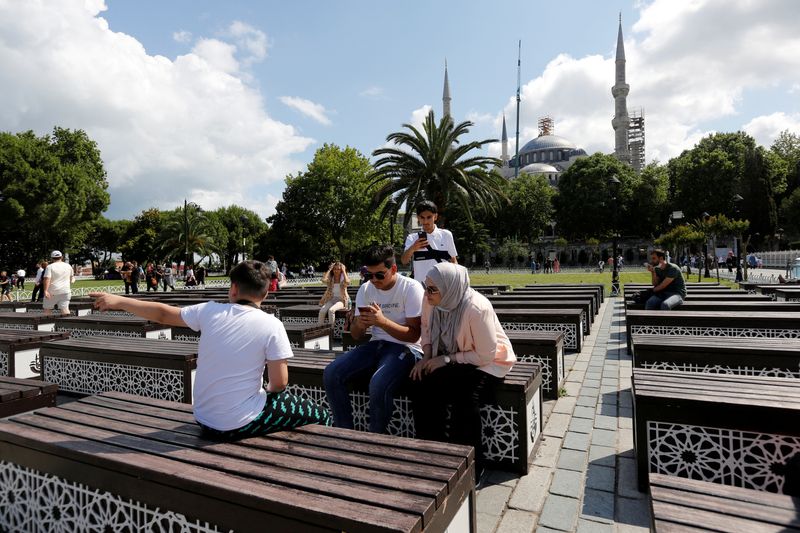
top-left (0, 0), bottom-right (314, 217)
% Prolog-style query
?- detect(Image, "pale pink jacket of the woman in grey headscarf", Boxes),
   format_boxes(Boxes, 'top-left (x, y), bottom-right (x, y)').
top-left (421, 292), bottom-right (517, 378)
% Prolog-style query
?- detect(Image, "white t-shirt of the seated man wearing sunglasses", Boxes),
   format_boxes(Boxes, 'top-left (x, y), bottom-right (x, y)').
top-left (356, 274), bottom-right (425, 350)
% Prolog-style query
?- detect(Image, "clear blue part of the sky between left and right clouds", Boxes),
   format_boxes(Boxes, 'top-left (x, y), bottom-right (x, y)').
top-left (103, 0), bottom-right (635, 157)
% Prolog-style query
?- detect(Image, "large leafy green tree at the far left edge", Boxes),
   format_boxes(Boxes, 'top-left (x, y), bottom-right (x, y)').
top-left (0, 127), bottom-right (109, 266)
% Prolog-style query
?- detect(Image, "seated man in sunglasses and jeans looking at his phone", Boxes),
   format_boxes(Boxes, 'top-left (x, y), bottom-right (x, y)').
top-left (323, 245), bottom-right (424, 433)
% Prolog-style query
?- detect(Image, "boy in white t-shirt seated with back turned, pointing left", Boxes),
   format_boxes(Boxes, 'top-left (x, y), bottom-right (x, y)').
top-left (89, 261), bottom-right (330, 439)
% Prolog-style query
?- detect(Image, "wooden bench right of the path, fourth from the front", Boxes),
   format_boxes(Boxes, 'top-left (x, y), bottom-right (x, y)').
top-left (625, 310), bottom-right (800, 353)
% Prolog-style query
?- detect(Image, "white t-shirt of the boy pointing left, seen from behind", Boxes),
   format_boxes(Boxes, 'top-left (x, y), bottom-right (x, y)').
top-left (181, 302), bottom-right (293, 431)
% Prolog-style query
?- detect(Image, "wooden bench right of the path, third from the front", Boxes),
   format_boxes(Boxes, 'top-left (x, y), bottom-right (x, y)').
top-left (633, 335), bottom-right (800, 378)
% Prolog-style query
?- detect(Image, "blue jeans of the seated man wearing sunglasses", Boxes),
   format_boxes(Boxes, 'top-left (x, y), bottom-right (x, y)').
top-left (322, 340), bottom-right (418, 433)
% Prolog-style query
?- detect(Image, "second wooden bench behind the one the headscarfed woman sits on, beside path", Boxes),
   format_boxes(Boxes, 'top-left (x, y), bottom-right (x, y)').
top-left (495, 309), bottom-right (584, 352)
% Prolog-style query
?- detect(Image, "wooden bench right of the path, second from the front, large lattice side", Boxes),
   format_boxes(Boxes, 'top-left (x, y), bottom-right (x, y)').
top-left (633, 368), bottom-right (800, 493)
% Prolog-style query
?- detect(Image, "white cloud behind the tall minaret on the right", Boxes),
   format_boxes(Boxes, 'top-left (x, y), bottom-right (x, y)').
top-left (492, 0), bottom-right (800, 161)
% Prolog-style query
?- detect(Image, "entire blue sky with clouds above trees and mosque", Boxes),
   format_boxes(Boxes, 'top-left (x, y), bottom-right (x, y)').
top-left (0, 0), bottom-right (800, 219)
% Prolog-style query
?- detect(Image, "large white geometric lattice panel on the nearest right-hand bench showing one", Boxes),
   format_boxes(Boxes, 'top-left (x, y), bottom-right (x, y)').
top-left (647, 420), bottom-right (800, 494)
